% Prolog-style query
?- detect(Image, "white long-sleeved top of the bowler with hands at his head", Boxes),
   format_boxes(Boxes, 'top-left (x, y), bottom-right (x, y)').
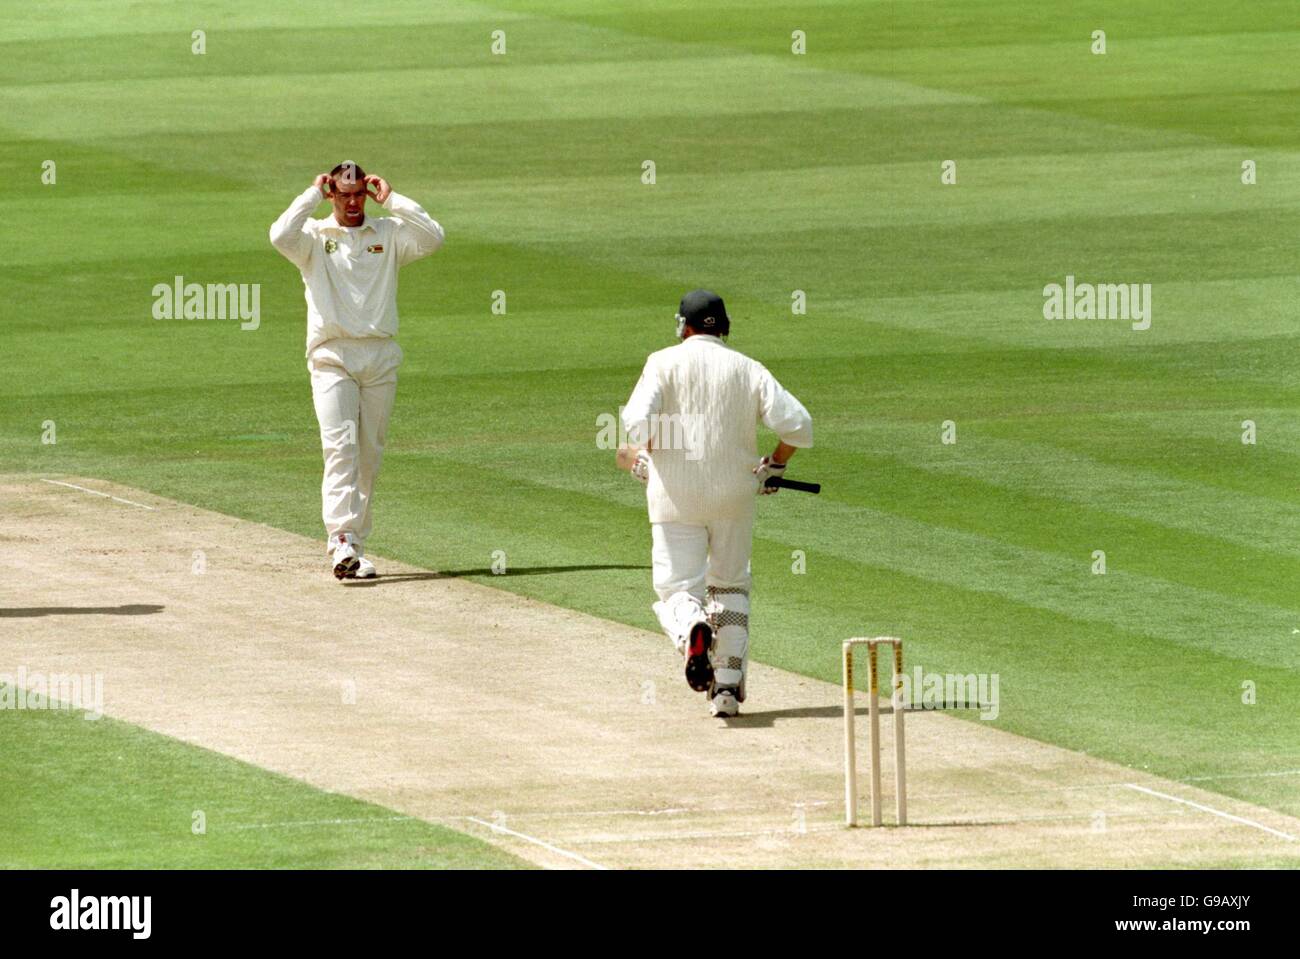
top-left (270, 186), bottom-right (443, 355)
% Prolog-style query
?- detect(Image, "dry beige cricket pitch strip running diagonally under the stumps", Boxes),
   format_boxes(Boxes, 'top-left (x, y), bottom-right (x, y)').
top-left (0, 477), bottom-right (1300, 868)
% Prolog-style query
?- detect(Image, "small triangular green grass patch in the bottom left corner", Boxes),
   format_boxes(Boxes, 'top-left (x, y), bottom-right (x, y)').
top-left (0, 686), bottom-right (521, 869)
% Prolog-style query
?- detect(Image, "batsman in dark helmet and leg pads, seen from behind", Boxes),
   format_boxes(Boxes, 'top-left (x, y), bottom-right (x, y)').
top-left (618, 290), bottom-right (813, 717)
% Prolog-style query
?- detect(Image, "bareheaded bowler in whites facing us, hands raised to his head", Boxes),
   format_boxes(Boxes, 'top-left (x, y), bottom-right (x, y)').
top-left (270, 161), bottom-right (443, 580)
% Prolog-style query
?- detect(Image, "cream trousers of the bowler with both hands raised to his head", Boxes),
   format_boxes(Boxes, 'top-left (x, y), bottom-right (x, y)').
top-left (307, 337), bottom-right (402, 548)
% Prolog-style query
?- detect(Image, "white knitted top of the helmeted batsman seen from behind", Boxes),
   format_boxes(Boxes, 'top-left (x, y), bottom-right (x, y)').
top-left (623, 334), bottom-right (813, 522)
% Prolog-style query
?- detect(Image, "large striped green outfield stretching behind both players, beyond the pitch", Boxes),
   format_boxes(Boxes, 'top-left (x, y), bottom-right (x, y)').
top-left (0, 0), bottom-right (1300, 864)
